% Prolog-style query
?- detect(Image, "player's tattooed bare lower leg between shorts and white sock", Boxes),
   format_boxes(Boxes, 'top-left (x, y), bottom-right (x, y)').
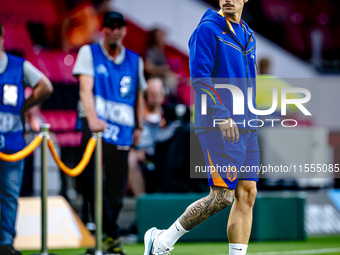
top-left (179, 186), bottom-right (235, 231)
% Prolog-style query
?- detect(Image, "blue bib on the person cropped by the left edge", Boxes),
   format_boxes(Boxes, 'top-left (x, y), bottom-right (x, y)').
top-left (0, 53), bottom-right (25, 153)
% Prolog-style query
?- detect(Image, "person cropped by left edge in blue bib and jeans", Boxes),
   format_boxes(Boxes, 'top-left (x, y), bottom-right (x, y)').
top-left (0, 24), bottom-right (53, 255)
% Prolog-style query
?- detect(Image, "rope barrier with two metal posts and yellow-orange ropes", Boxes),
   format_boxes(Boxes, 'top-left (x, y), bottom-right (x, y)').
top-left (0, 124), bottom-right (103, 255)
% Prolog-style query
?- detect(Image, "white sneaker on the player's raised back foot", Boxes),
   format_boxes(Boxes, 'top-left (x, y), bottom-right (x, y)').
top-left (144, 228), bottom-right (174, 255)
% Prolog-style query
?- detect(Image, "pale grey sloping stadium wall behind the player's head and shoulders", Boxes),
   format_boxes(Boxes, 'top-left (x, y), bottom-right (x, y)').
top-left (111, 0), bottom-right (318, 78)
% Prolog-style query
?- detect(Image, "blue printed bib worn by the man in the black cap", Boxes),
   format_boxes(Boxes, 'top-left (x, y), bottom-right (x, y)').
top-left (91, 44), bottom-right (139, 146)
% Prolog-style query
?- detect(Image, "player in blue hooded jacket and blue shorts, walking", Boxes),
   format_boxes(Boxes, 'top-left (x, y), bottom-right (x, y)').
top-left (144, 0), bottom-right (259, 255)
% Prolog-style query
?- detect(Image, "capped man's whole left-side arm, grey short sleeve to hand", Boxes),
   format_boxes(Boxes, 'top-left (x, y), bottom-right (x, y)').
top-left (73, 45), bottom-right (106, 132)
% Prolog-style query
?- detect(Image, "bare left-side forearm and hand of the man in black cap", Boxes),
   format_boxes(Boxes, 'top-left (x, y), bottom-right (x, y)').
top-left (79, 75), bottom-right (106, 132)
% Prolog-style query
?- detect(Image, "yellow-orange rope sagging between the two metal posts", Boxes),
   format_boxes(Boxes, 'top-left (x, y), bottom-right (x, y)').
top-left (47, 137), bottom-right (97, 177)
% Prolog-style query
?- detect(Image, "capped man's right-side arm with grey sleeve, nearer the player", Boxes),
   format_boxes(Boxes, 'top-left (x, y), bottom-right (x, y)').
top-left (133, 58), bottom-right (147, 145)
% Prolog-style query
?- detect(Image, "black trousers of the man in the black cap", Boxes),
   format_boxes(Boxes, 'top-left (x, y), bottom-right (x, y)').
top-left (79, 119), bottom-right (129, 238)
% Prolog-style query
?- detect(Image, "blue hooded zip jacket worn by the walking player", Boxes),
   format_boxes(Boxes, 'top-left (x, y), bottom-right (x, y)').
top-left (189, 9), bottom-right (257, 133)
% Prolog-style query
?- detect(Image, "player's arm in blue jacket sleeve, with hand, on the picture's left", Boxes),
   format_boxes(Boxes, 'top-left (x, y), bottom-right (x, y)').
top-left (189, 22), bottom-right (239, 143)
